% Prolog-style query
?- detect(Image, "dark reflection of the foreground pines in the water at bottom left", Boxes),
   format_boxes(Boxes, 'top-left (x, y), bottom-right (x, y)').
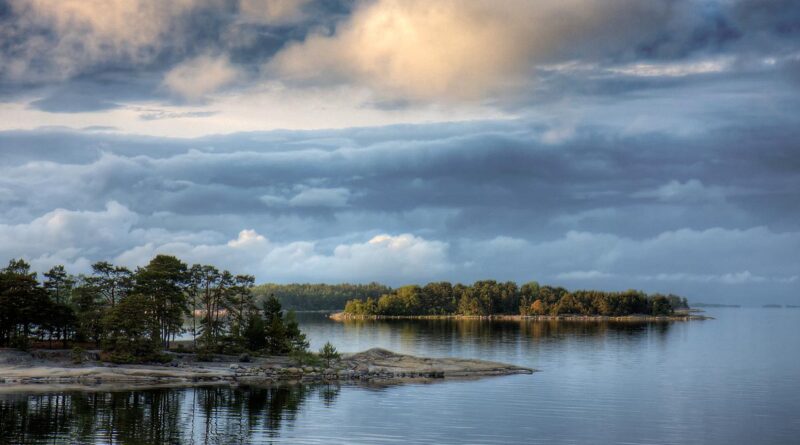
top-left (0, 385), bottom-right (340, 444)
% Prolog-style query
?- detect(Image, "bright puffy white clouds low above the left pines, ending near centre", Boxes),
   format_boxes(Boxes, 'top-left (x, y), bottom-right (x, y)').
top-left (0, 202), bottom-right (453, 283)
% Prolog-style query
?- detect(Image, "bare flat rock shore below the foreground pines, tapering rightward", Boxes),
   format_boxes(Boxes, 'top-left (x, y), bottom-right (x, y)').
top-left (0, 348), bottom-right (534, 392)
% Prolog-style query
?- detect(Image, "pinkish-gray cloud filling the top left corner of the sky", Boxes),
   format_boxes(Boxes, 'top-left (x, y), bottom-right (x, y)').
top-left (0, 0), bottom-right (197, 82)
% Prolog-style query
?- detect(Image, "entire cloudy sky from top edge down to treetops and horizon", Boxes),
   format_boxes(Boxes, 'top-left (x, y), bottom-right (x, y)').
top-left (0, 0), bottom-right (800, 305)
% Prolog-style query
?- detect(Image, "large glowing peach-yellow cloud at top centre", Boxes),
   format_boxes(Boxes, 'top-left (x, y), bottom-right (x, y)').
top-left (268, 0), bottom-right (666, 100)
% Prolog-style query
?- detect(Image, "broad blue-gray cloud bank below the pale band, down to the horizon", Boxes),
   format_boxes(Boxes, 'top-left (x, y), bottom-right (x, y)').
top-left (0, 120), bottom-right (800, 304)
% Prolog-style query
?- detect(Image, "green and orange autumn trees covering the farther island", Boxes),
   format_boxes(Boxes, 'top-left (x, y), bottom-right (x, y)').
top-left (344, 280), bottom-right (688, 316)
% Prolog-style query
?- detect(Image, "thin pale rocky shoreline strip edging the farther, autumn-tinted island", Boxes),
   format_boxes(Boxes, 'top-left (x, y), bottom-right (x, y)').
top-left (328, 312), bottom-right (714, 322)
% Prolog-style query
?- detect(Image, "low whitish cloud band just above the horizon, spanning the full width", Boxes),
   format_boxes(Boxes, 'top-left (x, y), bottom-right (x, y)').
top-left (0, 201), bottom-right (800, 293)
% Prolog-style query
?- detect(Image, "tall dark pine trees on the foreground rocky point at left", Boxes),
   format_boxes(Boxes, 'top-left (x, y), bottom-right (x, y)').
top-left (0, 255), bottom-right (308, 362)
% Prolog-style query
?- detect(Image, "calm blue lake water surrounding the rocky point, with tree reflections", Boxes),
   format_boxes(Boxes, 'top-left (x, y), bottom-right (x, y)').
top-left (0, 308), bottom-right (800, 445)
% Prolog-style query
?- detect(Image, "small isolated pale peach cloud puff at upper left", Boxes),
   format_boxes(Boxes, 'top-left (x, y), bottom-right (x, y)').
top-left (164, 56), bottom-right (240, 101)
